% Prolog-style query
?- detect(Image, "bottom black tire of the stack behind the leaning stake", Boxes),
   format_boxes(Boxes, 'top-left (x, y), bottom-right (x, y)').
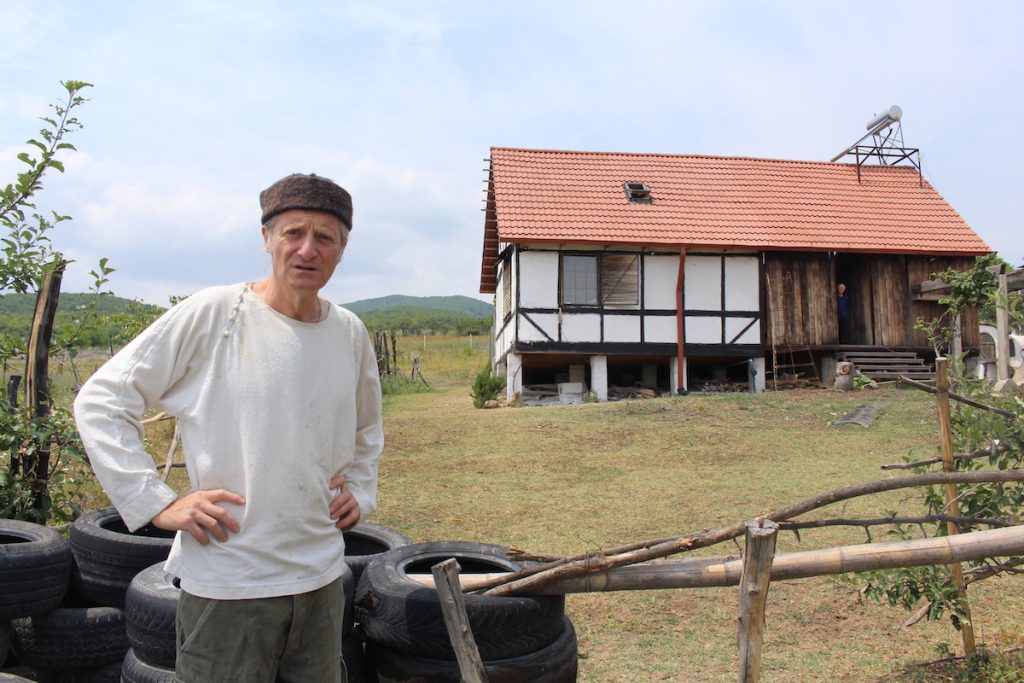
top-left (367, 618), bottom-right (579, 683)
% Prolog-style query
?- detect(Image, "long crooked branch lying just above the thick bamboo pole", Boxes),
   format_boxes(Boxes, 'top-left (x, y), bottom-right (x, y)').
top-left (482, 470), bottom-right (1024, 595)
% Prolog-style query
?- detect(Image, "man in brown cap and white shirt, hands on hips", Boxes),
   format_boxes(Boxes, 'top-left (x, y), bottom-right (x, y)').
top-left (75, 174), bottom-right (383, 683)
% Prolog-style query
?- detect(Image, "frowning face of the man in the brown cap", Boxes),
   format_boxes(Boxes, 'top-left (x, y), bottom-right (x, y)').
top-left (263, 209), bottom-right (346, 292)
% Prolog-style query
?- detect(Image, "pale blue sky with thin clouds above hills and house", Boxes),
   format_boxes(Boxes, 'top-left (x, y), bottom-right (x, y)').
top-left (0, 0), bottom-right (1024, 304)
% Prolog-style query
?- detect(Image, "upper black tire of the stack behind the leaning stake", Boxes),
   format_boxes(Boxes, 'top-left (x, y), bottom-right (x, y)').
top-left (355, 541), bottom-right (565, 660)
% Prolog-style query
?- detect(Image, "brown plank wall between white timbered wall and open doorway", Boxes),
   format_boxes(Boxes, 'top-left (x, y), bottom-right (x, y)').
top-left (765, 252), bottom-right (839, 347)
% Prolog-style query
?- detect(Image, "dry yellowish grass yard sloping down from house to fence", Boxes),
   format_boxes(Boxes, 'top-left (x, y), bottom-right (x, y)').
top-left (58, 338), bottom-right (1024, 683)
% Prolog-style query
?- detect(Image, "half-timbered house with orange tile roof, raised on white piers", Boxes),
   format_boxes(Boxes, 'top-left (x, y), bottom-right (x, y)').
top-left (480, 147), bottom-right (990, 399)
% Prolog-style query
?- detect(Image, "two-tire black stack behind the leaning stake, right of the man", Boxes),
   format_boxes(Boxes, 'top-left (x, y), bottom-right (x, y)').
top-left (355, 542), bottom-right (578, 683)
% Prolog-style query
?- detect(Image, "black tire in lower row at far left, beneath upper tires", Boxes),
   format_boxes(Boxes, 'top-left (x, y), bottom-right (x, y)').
top-left (11, 607), bottom-right (128, 670)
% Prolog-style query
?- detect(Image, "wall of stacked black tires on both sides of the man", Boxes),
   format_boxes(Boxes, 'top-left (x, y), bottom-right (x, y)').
top-left (8, 518), bottom-right (544, 683)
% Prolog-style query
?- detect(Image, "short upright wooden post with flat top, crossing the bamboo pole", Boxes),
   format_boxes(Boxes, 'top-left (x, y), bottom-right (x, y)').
top-left (738, 519), bottom-right (778, 683)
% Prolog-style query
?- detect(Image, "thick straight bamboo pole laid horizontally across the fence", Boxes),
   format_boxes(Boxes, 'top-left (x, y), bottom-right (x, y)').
top-left (408, 524), bottom-right (1024, 595)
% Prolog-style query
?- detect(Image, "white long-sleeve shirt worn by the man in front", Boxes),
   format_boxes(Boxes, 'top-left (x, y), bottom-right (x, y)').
top-left (75, 284), bottom-right (384, 599)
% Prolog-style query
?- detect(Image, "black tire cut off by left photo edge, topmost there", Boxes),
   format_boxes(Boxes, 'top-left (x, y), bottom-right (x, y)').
top-left (0, 519), bottom-right (72, 622)
